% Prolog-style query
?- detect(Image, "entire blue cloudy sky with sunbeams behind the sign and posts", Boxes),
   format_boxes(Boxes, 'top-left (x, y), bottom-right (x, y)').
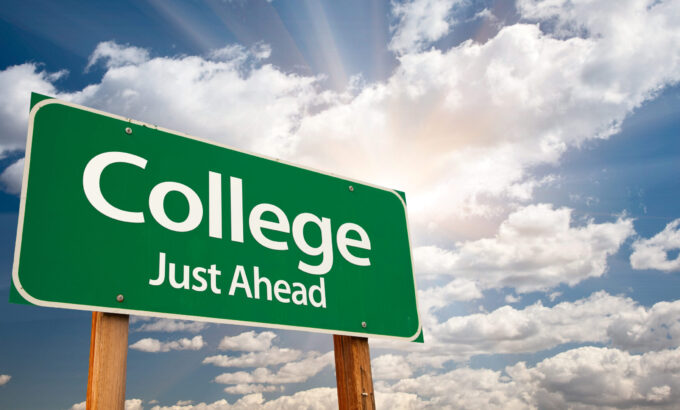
top-left (0, 0), bottom-right (680, 410)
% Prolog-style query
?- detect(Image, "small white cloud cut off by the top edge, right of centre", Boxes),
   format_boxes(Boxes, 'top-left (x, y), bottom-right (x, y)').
top-left (388, 0), bottom-right (461, 54)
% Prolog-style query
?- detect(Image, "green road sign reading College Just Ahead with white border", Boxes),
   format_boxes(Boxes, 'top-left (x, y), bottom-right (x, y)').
top-left (12, 95), bottom-right (420, 340)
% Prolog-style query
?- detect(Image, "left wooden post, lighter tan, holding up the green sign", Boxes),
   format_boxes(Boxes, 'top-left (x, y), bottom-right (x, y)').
top-left (86, 312), bottom-right (130, 410)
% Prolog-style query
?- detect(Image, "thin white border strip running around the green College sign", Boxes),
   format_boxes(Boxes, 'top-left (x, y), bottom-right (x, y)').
top-left (12, 98), bottom-right (422, 342)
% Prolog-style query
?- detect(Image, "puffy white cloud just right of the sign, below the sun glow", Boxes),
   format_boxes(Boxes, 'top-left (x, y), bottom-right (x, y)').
top-left (415, 204), bottom-right (634, 293)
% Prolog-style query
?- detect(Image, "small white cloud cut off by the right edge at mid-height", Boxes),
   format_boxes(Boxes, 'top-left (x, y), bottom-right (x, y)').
top-left (630, 219), bottom-right (680, 272)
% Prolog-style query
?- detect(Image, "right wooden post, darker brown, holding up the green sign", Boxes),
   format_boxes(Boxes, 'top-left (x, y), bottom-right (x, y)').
top-left (333, 335), bottom-right (375, 410)
